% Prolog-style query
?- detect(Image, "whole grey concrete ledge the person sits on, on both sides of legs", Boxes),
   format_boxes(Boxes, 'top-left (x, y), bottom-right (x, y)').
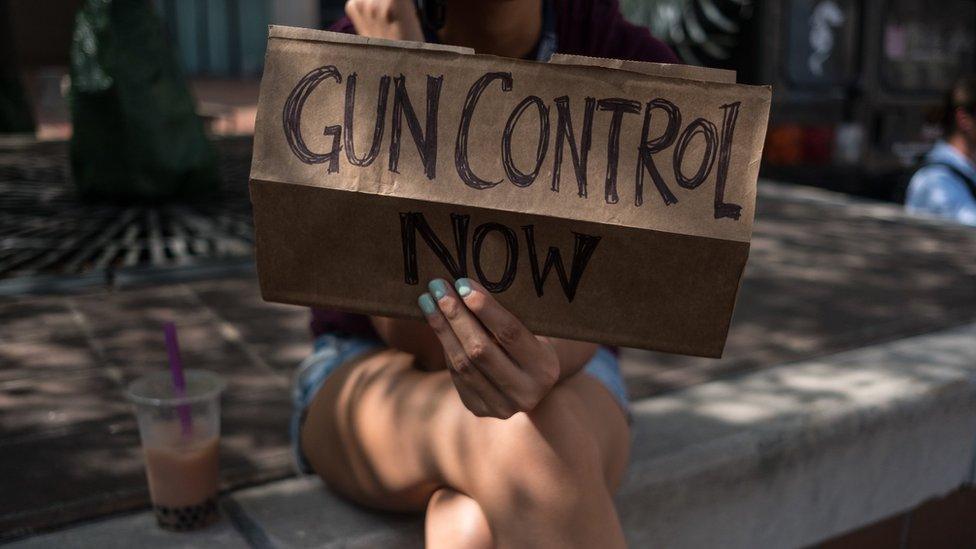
top-left (17, 324), bottom-right (976, 548)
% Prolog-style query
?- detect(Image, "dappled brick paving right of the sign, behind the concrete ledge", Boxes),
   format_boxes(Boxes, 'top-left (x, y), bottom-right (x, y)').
top-left (621, 184), bottom-right (976, 398)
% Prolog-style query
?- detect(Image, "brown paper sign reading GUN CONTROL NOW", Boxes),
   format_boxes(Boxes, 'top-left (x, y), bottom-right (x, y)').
top-left (250, 27), bottom-right (770, 357)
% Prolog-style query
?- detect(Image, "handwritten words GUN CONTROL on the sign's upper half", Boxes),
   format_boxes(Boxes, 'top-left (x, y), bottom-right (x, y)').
top-left (282, 65), bottom-right (742, 219)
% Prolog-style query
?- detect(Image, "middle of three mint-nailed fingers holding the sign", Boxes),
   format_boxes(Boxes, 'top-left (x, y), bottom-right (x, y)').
top-left (429, 278), bottom-right (532, 396)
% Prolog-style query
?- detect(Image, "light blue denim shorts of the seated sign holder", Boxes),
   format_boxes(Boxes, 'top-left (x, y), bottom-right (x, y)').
top-left (290, 334), bottom-right (630, 473)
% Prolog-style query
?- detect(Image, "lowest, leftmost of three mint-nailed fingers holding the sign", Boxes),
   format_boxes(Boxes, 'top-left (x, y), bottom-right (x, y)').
top-left (418, 294), bottom-right (516, 419)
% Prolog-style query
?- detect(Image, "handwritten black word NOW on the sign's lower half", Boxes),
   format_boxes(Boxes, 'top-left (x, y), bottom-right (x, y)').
top-left (400, 212), bottom-right (600, 302)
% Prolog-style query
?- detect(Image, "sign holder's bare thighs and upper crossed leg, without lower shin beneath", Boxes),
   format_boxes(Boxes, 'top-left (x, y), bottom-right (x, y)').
top-left (302, 350), bottom-right (630, 547)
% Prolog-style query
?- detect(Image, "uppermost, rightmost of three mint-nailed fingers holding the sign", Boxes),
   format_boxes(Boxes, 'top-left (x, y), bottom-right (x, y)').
top-left (455, 278), bottom-right (553, 382)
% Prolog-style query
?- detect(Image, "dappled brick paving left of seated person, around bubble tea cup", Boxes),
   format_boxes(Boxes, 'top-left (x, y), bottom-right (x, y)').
top-left (0, 278), bottom-right (310, 537)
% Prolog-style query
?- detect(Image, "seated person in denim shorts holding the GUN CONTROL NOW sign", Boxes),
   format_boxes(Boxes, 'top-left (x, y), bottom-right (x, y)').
top-left (292, 0), bottom-right (676, 547)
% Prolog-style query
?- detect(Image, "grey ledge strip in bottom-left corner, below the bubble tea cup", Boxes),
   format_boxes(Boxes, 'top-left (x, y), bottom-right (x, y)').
top-left (9, 512), bottom-right (248, 549)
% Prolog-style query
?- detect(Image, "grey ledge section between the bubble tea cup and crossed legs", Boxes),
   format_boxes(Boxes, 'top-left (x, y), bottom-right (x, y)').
top-left (233, 476), bottom-right (423, 548)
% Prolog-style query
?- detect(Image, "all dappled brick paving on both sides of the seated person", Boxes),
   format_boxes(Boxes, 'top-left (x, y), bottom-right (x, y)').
top-left (0, 139), bottom-right (976, 539)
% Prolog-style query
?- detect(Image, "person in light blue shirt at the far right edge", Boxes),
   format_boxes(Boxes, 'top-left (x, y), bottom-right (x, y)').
top-left (905, 75), bottom-right (976, 226)
